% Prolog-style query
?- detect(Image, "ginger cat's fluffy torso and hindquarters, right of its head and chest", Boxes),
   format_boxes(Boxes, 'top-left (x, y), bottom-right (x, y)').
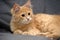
top-left (36, 13), bottom-right (60, 37)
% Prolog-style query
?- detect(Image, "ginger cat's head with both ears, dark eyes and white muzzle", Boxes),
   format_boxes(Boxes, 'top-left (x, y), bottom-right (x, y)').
top-left (11, 0), bottom-right (33, 24)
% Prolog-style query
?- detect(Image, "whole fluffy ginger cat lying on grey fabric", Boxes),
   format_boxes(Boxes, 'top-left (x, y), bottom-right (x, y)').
top-left (10, 0), bottom-right (60, 37)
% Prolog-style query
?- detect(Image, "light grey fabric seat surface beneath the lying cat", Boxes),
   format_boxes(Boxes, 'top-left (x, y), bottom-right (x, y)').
top-left (0, 33), bottom-right (52, 40)
